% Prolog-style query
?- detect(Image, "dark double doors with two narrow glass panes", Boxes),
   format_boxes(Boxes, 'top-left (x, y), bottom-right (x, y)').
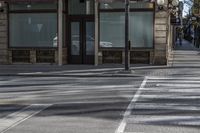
top-left (69, 18), bottom-right (95, 64)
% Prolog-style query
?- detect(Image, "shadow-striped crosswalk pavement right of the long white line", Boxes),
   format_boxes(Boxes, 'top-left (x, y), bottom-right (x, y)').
top-left (124, 77), bottom-right (200, 133)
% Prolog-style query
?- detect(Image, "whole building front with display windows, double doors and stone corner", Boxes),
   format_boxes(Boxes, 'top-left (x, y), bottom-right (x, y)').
top-left (0, 0), bottom-right (172, 65)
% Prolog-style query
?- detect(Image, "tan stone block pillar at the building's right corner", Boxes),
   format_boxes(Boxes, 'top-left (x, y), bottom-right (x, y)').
top-left (153, 11), bottom-right (169, 65)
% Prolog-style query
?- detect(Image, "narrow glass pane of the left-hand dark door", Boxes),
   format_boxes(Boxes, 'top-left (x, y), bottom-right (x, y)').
top-left (71, 22), bottom-right (80, 55)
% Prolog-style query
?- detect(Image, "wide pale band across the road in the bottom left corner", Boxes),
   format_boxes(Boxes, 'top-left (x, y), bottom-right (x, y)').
top-left (0, 104), bottom-right (52, 133)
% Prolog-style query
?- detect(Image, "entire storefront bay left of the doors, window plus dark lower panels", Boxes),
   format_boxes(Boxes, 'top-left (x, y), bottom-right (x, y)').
top-left (8, 0), bottom-right (58, 63)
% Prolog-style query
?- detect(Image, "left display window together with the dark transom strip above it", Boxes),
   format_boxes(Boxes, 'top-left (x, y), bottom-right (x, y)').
top-left (9, 2), bottom-right (57, 47)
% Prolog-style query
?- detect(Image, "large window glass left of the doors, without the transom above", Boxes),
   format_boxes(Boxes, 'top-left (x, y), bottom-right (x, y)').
top-left (9, 13), bottom-right (57, 47)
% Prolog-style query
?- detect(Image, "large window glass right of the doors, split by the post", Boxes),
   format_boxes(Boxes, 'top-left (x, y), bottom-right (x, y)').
top-left (100, 12), bottom-right (153, 48)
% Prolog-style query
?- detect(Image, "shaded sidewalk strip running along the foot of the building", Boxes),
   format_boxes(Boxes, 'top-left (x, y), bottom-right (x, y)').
top-left (0, 64), bottom-right (167, 77)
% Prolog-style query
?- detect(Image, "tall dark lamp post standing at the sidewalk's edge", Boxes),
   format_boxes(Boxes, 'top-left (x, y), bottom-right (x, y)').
top-left (125, 0), bottom-right (130, 71)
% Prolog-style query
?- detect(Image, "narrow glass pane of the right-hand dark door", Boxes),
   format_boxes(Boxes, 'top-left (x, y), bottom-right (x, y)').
top-left (86, 22), bottom-right (94, 55)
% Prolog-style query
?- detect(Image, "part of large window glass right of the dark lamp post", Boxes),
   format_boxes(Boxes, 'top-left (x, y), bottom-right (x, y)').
top-left (129, 12), bottom-right (153, 48)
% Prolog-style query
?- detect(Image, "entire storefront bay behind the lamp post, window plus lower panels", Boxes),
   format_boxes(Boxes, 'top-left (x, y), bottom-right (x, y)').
top-left (99, 0), bottom-right (154, 64)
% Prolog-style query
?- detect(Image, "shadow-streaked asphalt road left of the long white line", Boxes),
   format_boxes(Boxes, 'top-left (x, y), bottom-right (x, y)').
top-left (0, 76), bottom-right (143, 133)
